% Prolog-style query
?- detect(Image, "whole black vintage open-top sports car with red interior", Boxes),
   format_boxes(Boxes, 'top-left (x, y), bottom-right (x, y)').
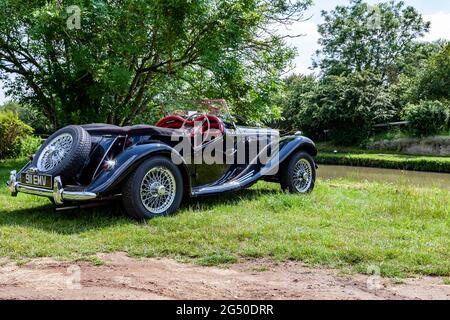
top-left (8, 100), bottom-right (317, 219)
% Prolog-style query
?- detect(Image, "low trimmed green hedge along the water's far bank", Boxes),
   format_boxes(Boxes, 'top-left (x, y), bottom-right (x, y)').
top-left (316, 153), bottom-right (450, 173)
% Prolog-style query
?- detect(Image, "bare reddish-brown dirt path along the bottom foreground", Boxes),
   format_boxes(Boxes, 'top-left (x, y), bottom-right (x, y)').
top-left (0, 253), bottom-right (450, 299)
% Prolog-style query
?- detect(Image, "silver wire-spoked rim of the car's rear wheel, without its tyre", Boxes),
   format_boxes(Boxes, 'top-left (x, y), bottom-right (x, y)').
top-left (140, 167), bottom-right (176, 214)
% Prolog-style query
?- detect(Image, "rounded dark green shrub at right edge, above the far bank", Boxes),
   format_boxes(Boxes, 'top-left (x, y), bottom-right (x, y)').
top-left (402, 101), bottom-right (449, 137)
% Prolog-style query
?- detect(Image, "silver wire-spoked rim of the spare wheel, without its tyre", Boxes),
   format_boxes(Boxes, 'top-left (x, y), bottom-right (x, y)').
top-left (36, 133), bottom-right (73, 172)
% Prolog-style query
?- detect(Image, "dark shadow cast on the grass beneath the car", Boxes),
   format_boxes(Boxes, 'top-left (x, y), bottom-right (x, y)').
top-left (0, 185), bottom-right (277, 235)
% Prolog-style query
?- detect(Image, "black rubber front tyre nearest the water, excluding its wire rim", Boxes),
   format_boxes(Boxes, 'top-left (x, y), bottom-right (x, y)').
top-left (280, 151), bottom-right (316, 193)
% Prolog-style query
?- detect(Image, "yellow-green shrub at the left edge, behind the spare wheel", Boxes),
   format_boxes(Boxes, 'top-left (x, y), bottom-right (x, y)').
top-left (0, 112), bottom-right (33, 159)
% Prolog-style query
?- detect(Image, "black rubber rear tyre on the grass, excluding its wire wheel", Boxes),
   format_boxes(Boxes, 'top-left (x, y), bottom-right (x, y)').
top-left (122, 156), bottom-right (183, 219)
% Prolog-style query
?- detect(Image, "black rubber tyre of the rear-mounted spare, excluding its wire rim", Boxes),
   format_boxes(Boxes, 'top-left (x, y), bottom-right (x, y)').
top-left (32, 126), bottom-right (91, 182)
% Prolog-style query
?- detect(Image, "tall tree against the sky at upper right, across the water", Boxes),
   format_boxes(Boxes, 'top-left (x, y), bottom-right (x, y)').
top-left (315, 0), bottom-right (430, 84)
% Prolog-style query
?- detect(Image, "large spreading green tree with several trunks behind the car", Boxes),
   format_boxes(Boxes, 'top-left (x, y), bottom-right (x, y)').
top-left (0, 0), bottom-right (311, 127)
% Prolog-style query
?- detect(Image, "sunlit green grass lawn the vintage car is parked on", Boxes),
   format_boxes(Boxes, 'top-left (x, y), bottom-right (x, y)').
top-left (0, 161), bottom-right (450, 277)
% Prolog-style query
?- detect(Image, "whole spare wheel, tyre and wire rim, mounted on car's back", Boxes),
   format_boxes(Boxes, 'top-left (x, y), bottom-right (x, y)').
top-left (32, 126), bottom-right (91, 180)
